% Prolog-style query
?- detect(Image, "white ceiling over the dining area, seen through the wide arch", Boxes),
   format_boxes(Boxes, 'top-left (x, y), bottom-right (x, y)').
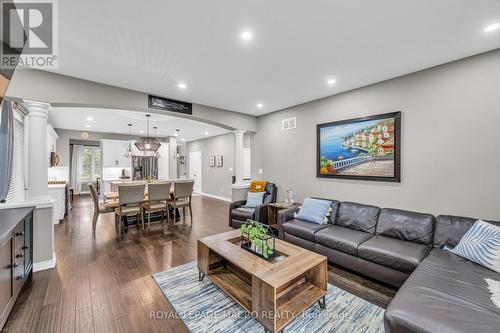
top-left (49, 107), bottom-right (229, 142)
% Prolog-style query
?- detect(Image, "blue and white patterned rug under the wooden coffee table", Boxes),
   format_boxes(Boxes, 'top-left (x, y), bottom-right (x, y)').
top-left (152, 262), bottom-right (384, 333)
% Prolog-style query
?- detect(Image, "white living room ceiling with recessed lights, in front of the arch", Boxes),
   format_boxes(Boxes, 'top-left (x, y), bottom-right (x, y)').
top-left (43, 0), bottom-right (500, 115)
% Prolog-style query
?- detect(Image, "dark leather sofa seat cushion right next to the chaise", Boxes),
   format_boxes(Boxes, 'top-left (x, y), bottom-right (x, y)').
top-left (358, 235), bottom-right (431, 273)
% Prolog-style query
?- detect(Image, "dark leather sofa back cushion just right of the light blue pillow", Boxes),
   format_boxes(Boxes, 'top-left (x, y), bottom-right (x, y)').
top-left (335, 202), bottom-right (380, 234)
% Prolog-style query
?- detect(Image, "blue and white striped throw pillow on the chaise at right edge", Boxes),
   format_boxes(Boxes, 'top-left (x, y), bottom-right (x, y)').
top-left (444, 220), bottom-right (500, 273)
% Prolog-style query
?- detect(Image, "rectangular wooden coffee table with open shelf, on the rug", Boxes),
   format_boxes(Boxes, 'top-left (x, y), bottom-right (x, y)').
top-left (198, 230), bottom-right (328, 332)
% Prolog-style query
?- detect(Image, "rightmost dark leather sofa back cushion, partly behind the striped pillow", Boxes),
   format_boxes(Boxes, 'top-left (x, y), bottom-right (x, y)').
top-left (434, 215), bottom-right (500, 248)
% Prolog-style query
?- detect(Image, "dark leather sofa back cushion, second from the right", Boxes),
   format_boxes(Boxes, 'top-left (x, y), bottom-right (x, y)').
top-left (376, 208), bottom-right (436, 245)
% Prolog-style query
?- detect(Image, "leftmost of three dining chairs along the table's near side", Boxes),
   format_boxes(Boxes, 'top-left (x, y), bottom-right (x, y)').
top-left (115, 184), bottom-right (146, 234)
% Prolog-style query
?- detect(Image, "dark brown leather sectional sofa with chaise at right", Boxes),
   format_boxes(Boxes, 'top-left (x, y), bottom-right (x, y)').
top-left (279, 201), bottom-right (500, 333)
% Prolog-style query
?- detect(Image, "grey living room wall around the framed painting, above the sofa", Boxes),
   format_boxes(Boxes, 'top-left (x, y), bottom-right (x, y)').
top-left (252, 51), bottom-right (500, 220)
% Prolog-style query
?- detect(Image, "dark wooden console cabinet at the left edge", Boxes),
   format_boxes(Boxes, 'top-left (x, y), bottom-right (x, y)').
top-left (0, 207), bottom-right (34, 330)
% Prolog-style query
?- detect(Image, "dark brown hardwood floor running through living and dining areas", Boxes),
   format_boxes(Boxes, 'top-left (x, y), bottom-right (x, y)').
top-left (3, 196), bottom-right (394, 333)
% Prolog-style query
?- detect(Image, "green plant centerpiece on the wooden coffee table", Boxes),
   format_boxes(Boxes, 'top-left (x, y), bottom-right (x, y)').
top-left (240, 220), bottom-right (276, 260)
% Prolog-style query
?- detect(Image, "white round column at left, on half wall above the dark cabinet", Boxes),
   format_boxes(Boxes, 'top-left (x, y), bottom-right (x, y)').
top-left (23, 100), bottom-right (50, 199)
